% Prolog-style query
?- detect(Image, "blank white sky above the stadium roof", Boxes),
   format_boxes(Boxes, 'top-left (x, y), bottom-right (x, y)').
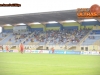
top-left (0, 0), bottom-right (100, 16)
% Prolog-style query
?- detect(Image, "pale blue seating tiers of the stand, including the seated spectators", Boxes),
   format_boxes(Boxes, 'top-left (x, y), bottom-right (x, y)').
top-left (0, 24), bottom-right (100, 49)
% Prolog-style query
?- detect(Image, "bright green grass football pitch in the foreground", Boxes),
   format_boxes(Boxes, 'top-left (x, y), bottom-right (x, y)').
top-left (0, 53), bottom-right (100, 75)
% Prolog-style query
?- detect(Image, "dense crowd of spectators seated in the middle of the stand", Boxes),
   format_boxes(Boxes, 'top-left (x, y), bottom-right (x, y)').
top-left (0, 29), bottom-right (90, 44)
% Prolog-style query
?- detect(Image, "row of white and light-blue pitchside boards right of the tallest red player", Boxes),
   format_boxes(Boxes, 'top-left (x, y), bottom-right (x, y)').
top-left (24, 50), bottom-right (100, 55)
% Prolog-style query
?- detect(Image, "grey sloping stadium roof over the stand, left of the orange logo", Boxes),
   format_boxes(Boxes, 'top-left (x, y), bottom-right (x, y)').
top-left (0, 10), bottom-right (98, 25)
